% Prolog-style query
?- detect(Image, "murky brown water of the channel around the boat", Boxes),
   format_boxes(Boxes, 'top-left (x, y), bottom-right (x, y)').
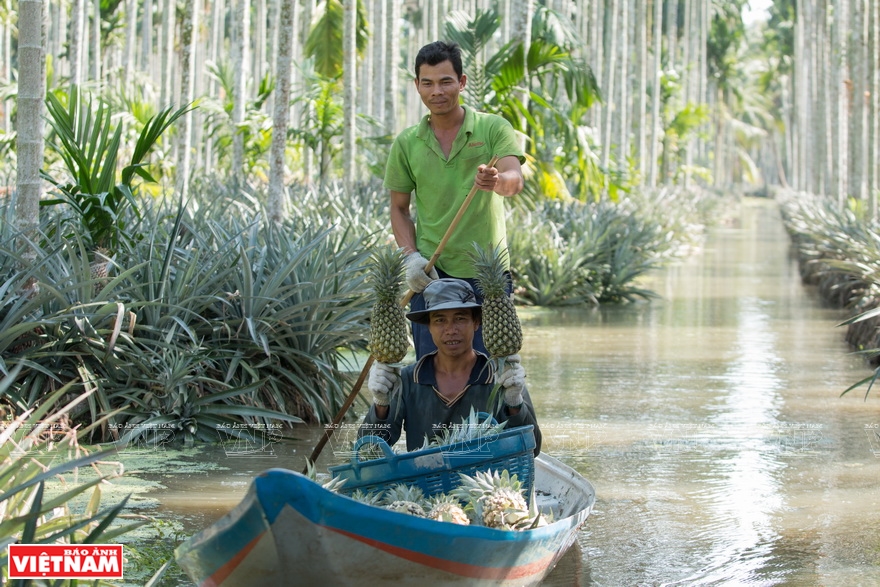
top-left (134, 199), bottom-right (880, 587)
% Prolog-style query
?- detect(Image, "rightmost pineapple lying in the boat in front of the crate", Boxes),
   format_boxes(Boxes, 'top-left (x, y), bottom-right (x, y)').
top-left (452, 469), bottom-right (532, 530)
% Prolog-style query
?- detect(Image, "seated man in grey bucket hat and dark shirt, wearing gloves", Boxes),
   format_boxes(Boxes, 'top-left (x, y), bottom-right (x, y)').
top-left (358, 278), bottom-right (541, 455)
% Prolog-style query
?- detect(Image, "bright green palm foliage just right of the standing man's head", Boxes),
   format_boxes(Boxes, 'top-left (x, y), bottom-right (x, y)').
top-left (446, 6), bottom-right (605, 201)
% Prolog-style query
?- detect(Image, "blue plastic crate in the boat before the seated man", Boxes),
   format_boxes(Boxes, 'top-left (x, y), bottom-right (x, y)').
top-left (329, 425), bottom-right (535, 504)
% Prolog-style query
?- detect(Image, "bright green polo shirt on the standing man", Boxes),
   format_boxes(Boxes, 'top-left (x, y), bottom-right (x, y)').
top-left (385, 107), bottom-right (525, 277)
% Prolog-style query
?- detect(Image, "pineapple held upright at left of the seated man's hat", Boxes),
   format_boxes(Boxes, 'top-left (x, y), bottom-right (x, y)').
top-left (370, 249), bottom-right (409, 363)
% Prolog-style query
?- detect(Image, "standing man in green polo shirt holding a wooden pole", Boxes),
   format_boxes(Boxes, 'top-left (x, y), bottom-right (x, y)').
top-left (385, 41), bottom-right (525, 357)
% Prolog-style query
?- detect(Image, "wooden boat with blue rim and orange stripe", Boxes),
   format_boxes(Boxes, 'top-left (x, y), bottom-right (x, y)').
top-left (176, 454), bottom-right (595, 587)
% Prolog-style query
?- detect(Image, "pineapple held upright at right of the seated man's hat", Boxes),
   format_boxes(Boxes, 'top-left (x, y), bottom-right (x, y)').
top-left (471, 243), bottom-right (522, 359)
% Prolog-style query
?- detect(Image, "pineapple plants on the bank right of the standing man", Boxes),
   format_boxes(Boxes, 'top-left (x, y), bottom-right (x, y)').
top-left (508, 191), bottom-right (720, 306)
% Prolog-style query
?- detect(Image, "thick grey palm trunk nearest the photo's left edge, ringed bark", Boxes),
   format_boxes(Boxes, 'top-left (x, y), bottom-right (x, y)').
top-left (15, 0), bottom-right (46, 263)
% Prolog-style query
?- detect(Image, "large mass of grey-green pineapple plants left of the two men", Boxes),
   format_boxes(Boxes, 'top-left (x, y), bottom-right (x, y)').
top-left (0, 183), bottom-right (388, 443)
